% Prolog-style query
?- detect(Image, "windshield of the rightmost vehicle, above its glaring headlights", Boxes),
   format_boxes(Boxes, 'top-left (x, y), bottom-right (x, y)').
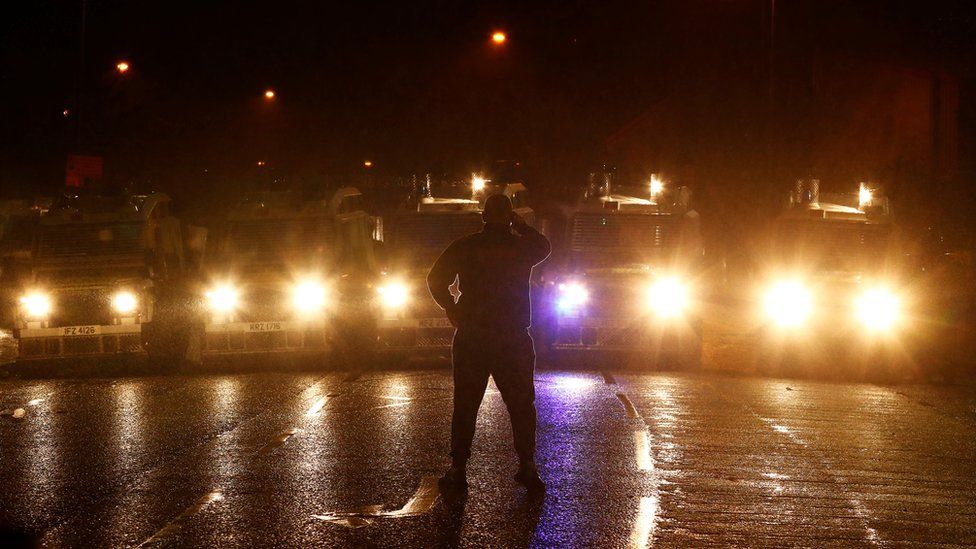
top-left (775, 216), bottom-right (892, 272)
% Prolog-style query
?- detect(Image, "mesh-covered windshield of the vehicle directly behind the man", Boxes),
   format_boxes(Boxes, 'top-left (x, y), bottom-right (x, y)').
top-left (394, 212), bottom-right (482, 266)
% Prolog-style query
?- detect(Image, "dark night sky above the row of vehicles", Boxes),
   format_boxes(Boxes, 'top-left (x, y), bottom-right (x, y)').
top-left (0, 0), bottom-right (976, 216)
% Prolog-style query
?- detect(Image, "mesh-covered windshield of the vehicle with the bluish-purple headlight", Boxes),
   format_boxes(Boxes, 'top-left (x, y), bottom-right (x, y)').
top-left (570, 212), bottom-right (680, 269)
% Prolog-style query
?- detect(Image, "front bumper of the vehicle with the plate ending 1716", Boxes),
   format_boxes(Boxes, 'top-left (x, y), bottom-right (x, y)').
top-left (203, 320), bottom-right (331, 357)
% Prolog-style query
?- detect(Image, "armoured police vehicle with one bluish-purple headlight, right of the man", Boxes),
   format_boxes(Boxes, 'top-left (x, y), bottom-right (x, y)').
top-left (534, 172), bottom-right (703, 368)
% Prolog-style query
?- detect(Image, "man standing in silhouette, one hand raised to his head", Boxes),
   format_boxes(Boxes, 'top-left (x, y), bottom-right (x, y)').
top-left (427, 194), bottom-right (550, 491)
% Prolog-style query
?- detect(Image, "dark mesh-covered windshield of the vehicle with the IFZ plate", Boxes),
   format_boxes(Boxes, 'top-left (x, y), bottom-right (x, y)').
top-left (37, 223), bottom-right (143, 259)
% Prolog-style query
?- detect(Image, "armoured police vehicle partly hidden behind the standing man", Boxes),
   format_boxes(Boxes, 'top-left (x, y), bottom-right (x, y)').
top-left (377, 176), bottom-right (535, 359)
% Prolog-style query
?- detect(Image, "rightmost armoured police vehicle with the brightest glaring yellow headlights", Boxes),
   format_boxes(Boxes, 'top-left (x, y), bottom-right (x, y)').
top-left (758, 180), bottom-right (908, 374)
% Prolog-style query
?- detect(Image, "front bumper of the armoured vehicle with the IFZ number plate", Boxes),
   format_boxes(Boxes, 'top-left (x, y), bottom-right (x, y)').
top-left (17, 324), bottom-right (145, 361)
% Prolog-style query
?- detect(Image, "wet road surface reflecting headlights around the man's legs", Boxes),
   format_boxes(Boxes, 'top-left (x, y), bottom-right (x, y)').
top-left (0, 369), bottom-right (976, 547)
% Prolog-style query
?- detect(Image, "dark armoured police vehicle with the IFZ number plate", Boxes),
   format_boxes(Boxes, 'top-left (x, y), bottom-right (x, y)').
top-left (16, 189), bottom-right (183, 360)
